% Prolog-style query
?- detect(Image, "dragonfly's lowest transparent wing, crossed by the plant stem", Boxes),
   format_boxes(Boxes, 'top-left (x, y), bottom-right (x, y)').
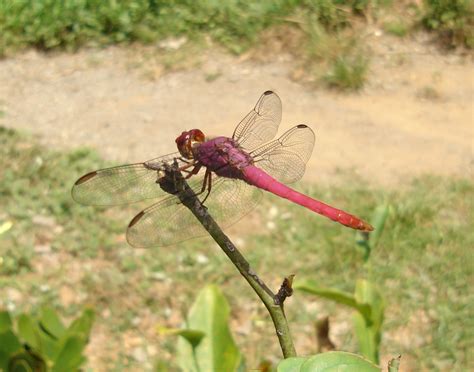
top-left (127, 178), bottom-right (262, 248)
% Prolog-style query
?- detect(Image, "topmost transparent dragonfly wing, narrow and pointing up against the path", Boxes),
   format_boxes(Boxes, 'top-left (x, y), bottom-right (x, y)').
top-left (232, 90), bottom-right (281, 151)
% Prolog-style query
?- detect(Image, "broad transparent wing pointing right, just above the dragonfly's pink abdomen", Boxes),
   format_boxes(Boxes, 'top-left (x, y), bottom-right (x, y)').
top-left (250, 124), bottom-right (315, 184)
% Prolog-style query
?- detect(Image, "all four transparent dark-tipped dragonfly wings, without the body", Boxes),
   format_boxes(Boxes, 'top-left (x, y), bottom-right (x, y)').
top-left (72, 91), bottom-right (314, 247)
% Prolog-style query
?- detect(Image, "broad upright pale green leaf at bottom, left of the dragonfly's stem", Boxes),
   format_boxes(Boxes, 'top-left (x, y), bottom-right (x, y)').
top-left (178, 285), bottom-right (243, 372)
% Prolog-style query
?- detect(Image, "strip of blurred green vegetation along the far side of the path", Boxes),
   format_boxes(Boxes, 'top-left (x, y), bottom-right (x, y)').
top-left (0, 0), bottom-right (474, 90)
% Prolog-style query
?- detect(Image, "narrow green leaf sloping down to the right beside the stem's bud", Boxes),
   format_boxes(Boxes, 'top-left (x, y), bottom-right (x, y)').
top-left (293, 280), bottom-right (371, 319)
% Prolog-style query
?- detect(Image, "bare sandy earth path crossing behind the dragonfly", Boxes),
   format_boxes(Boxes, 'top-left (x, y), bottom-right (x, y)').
top-left (0, 37), bottom-right (474, 185)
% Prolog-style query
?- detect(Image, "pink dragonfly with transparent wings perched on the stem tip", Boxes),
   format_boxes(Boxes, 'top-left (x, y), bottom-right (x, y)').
top-left (72, 91), bottom-right (373, 247)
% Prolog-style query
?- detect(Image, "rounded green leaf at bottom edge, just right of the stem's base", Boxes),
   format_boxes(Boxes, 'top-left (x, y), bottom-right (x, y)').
top-left (299, 351), bottom-right (381, 372)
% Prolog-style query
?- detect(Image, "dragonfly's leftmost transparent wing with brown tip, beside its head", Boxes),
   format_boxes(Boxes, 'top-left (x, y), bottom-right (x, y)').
top-left (71, 153), bottom-right (199, 206)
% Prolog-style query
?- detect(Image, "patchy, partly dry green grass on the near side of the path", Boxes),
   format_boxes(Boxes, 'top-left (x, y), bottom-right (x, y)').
top-left (0, 129), bottom-right (474, 370)
